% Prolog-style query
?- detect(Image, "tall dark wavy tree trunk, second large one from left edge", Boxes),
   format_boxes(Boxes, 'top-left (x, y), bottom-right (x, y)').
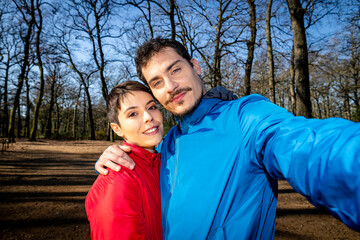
top-left (29, 3), bottom-right (45, 141)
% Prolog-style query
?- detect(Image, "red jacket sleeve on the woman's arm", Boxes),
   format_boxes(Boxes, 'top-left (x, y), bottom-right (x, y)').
top-left (85, 170), bottom-right (146, 240)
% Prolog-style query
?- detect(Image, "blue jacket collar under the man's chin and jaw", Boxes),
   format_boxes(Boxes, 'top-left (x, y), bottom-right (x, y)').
top-left (177, 98), bottom-right (221, 134)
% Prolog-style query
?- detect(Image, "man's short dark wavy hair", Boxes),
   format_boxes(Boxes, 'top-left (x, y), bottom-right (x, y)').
top-left (135, 37), bottom-right (193, 86)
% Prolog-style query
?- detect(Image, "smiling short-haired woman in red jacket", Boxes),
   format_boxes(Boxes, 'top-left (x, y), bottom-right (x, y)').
top-left (85, 81), bottom-right (164, 240)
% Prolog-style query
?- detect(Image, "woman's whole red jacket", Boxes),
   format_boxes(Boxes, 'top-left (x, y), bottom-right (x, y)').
top-left (85, 142), bottom-right (162, 240)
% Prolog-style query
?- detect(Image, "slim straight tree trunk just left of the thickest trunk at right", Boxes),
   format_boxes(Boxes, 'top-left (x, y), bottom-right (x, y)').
top-left (266, 0), bottom-right (276, 103)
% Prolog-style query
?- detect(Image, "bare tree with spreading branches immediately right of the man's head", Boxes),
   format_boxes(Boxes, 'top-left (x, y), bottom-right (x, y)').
top-left (177, 0), bottom-right (250, 87)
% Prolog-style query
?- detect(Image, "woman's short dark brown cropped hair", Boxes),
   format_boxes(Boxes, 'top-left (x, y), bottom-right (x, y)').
top-left (106, 81), bottom-right (152, 126)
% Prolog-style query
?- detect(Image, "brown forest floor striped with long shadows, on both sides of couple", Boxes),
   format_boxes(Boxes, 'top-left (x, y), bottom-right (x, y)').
top-left (0, 139), bottom-right (360, 240)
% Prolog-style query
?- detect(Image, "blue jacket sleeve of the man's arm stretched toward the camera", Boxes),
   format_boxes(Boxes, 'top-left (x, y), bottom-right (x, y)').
top-left (239, 96), bottom-right (360, 231)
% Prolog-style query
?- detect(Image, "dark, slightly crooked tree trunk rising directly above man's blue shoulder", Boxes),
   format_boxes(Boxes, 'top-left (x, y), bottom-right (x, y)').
top-left (244, 0), bottom-right (256, 95)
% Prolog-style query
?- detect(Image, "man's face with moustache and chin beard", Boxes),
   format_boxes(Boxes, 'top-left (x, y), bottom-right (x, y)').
top-left (142, 48), bottom-right (205, 116)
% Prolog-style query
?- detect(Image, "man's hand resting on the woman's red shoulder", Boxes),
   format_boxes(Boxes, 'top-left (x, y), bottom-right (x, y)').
top-left (95, 145), bottom-right (135, 175)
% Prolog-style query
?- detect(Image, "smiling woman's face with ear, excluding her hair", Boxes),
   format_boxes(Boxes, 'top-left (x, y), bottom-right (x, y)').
top-left (112, 91), bottom-right (164, 150)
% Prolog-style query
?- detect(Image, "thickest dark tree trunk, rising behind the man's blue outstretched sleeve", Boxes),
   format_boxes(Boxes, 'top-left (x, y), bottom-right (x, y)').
top-left (287, 0), bottom-right (311, 118)
